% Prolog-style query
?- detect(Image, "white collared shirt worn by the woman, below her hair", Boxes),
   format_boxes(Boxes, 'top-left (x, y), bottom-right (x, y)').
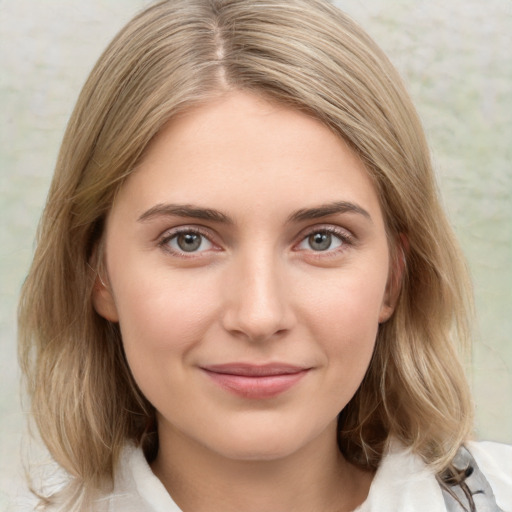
top-left (8, 442), bottom-right (512, 512)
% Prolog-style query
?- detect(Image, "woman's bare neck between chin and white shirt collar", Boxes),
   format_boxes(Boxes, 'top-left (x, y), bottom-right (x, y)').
top-left (152, 425), bottom-right (373, 512)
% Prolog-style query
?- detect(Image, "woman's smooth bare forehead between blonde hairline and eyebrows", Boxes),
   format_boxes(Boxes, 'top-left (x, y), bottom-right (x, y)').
top-left (113, 92), bottom-right (380, 228)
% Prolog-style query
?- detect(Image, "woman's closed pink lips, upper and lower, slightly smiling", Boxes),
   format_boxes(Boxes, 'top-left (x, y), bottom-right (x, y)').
top-left (201, 363), bottom-right (311, 400)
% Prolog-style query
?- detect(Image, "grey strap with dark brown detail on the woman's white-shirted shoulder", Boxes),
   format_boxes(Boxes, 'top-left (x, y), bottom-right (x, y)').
top-left (438, 446), bottom-right (503, 512)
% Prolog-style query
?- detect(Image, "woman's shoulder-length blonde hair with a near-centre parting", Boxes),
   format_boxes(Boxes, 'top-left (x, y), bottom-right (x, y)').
top-left (19, 0), bottom-right (472, 510)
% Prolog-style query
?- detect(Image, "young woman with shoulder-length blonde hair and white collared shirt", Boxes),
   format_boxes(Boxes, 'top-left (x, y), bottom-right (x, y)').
top-left (20, 0), bottom-right (512, 512)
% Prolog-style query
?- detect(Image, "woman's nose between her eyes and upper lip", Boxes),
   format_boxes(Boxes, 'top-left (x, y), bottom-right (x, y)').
top-left (222, 252), bottom-right (295, 342)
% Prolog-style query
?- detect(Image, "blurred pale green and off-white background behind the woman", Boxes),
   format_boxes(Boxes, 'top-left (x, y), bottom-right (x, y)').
top-left (0, 0), bottom-right (512, 510)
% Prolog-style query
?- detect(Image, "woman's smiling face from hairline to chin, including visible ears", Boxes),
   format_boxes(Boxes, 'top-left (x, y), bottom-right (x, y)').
top-left (94, 93), bottom-right (392, 460)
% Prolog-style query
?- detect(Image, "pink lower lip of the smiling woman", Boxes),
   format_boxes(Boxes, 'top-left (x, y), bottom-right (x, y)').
top-left (204, 370), bottom-right (308, 400)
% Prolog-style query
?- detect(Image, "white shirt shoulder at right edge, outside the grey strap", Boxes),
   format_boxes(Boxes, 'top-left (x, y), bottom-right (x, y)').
top-left (466, 441), bottom-right (512, 512)
